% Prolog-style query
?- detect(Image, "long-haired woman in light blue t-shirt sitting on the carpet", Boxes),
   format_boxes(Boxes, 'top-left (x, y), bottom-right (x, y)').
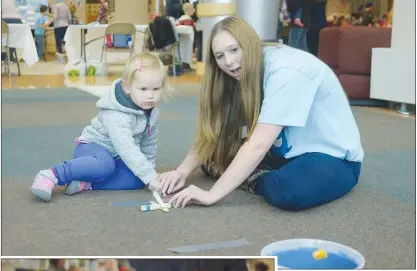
top-left (159, 17), bottom-right (364, 210)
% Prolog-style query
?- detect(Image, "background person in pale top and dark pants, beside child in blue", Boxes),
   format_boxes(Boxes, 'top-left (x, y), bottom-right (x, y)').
top-left (54, 0), bottom-right (71, 62)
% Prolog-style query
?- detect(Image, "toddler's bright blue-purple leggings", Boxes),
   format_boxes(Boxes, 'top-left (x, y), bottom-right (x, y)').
top-left (53, 143), bottom-right (145, 190)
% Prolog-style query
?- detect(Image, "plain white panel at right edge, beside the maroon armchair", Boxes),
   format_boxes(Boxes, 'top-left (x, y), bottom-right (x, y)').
top-left (370, 0), bottom-right (416, 104)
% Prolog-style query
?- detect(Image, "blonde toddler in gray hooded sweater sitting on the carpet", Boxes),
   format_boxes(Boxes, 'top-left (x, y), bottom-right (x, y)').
top-left (31, 53), bottom-right (168, 202)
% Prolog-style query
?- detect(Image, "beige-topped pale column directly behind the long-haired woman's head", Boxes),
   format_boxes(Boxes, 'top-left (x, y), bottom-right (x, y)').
top-left (197, 0), bottom-right (234, 75)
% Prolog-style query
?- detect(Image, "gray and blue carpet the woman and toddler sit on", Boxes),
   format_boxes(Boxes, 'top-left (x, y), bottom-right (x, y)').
top-left (2, 87), bottom-right (416, 269)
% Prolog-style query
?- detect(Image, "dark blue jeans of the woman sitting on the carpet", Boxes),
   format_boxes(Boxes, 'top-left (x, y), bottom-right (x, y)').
top-left (203, 153), bottom-right (361, 211)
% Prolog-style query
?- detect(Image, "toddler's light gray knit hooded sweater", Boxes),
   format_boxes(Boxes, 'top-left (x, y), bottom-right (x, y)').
top-left (78, 79), bottom-right (159, 184)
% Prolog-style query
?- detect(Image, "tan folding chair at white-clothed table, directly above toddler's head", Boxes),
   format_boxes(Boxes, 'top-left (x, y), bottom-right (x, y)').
top-left (100, 23), bottom-right (136, 63)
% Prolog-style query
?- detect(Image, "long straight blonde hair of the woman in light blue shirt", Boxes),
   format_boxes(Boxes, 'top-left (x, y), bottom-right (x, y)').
top-left (194, 17), bottom-right (263, 176)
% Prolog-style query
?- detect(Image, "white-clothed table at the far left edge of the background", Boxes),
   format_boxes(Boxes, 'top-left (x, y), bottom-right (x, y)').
top-left (1, 24), bottom-right (39, 66)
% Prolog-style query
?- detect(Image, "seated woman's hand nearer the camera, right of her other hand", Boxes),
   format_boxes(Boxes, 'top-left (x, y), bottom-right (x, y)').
top-left (169, 185), bottom-right (216, 208)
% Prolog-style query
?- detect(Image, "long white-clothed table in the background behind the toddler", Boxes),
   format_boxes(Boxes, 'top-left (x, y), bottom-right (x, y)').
top-left (64, 24), bottom-right (194, 64)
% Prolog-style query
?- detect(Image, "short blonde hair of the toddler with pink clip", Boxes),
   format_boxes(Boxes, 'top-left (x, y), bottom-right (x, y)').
top-left (122, 53), bottom-right (173, 98)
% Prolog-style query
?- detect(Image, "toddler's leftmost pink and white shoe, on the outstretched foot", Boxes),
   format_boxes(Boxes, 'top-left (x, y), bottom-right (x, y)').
top-left (30, 169), bottom-right (58, 202)
